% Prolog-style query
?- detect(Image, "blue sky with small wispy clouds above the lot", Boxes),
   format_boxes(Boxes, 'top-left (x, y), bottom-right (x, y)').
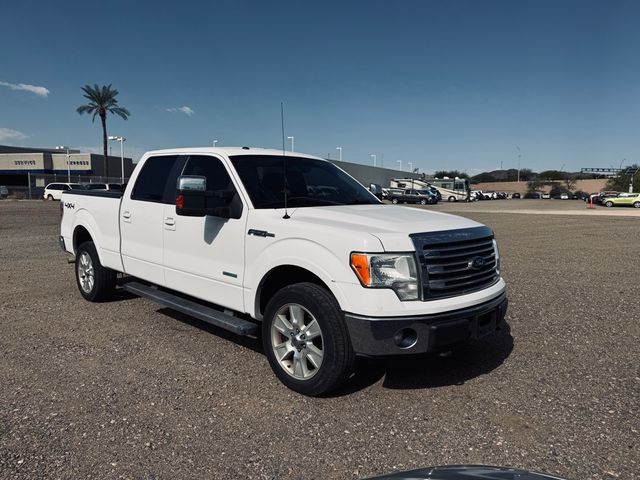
top-left (0, 0), bottom-right (640, 174)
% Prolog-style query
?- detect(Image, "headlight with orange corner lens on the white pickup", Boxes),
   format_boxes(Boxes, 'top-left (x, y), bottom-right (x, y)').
top-left (351, 253), bottom-right (419, 301)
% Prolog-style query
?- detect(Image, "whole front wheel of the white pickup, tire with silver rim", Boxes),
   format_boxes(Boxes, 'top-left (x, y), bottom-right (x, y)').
top-left (262, 283), bottom-right (355, 396)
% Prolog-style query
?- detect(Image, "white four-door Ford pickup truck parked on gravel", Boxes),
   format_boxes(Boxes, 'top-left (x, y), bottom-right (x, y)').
top-left (60, 147), bottom-right (507, 395)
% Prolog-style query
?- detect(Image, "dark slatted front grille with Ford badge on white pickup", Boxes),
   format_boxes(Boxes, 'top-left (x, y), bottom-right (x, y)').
top-left (410, 227), bottom-right (500, 300)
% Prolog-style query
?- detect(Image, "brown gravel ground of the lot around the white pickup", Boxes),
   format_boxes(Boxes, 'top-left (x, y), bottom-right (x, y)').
top-left (0, 201), bottom-right (640, 480)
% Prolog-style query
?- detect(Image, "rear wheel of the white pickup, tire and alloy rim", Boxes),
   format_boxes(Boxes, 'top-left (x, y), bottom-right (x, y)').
top-left (76, 242), bottom-right (117, 302)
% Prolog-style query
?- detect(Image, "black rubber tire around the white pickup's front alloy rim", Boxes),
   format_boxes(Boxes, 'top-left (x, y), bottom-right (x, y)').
top-left (262, 283), bottom-right (355, 396)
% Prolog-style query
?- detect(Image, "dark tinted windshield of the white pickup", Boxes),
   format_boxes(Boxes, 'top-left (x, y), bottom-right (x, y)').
top-left (231, 155), bottom-right (380, 208)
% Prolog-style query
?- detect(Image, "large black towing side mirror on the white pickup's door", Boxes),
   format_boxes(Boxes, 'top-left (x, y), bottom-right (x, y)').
top-left (176, 175), bottom-right (242, 218)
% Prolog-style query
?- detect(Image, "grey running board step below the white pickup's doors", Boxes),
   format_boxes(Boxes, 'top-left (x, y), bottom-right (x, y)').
top-left (122, 282), bottom-right (258, 336)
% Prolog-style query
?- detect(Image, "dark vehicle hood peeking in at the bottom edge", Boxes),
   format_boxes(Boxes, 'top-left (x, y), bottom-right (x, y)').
top-left (362, 465), bottom-right (563, 480)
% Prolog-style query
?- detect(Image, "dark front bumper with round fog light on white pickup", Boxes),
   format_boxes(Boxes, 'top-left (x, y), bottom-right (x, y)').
top-left (345, 292), bottom-right (508, 357)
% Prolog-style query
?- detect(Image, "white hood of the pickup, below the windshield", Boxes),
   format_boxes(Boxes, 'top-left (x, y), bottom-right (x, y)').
top-left (289, 205), bottom-right (481, 251)
